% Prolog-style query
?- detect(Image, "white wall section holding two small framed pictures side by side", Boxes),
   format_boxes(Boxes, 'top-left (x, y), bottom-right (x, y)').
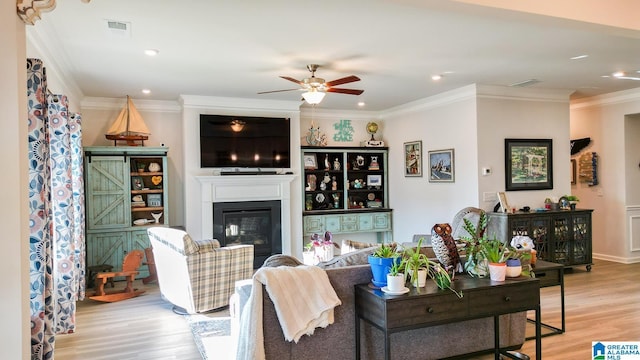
top-left (381, 86), bottom-right (478, 243)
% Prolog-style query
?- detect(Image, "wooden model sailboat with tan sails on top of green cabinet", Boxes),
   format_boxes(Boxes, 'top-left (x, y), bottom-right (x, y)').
top-left (105, 95), bottom-right (150, 146)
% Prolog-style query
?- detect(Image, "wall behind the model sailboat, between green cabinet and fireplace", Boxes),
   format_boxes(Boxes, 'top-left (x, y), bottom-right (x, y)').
top-left (80, 97), bottom-right (185, 226)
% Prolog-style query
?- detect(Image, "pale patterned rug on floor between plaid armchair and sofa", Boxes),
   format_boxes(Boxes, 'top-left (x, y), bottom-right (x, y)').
top-left (184, 314), bottom-right (236, 360)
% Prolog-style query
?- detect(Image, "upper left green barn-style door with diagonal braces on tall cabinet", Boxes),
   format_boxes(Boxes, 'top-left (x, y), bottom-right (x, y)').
top-left (85, 156), bottom-right (131, 230)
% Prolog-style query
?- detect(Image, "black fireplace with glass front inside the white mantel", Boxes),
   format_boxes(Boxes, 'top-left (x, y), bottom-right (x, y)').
top-left (213, 200), bottom-right (282, 269)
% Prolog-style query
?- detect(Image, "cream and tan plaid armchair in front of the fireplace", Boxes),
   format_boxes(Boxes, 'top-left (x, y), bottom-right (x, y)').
top-left (147, 227), bottom-right (253, 314)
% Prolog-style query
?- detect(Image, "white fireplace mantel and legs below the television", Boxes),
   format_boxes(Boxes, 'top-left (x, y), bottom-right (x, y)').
top-left (196, 175), bottom-right (295, 254)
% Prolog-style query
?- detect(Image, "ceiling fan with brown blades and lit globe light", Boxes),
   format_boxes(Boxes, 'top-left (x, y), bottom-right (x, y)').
top-left (258, 64), bottom-right (364, 105)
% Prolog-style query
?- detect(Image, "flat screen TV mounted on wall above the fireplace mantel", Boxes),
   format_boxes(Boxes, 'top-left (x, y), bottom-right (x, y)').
top-left (200, 114), bottom-right (291, 168)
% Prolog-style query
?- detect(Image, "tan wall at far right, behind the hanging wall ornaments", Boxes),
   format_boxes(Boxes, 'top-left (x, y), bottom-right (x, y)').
top-left (571, 89), bottom-right (640, 263)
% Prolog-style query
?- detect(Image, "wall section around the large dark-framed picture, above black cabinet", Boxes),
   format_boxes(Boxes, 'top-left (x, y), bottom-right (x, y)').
top-left (476, 86), bottom-right (571, 211)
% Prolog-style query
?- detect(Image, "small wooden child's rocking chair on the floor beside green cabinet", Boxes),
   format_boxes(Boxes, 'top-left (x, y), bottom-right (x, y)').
top-left (89, 250), bottom-right (145, 302)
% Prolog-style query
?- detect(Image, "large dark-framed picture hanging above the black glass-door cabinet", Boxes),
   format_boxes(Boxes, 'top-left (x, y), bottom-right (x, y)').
top-left (504, 139), bottom-right (553, 191)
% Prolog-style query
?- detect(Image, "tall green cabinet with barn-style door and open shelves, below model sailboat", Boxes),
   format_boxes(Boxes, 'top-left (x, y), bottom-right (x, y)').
top-left (84, 146), bottom-right (169, 278)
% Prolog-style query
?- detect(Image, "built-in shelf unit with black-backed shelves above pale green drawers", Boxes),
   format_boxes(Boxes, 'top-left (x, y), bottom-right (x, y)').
top-left (301, 146), bottom-right (392, 241)
